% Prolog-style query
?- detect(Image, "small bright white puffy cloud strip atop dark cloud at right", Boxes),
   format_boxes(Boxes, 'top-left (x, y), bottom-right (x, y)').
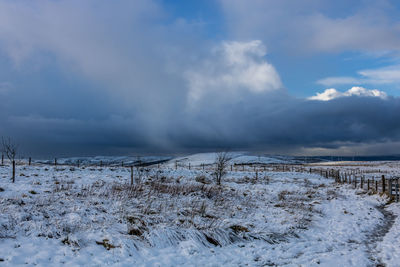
top-left (308, 86), bottom-right (387, 101)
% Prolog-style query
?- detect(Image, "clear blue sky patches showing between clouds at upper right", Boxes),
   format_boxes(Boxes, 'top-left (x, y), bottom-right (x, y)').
top-left (163, 0), bottom-right (400, 97)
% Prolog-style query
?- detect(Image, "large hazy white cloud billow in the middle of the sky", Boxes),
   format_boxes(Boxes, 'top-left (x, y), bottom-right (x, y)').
top-left (185, 40), bottom-right (283, 104)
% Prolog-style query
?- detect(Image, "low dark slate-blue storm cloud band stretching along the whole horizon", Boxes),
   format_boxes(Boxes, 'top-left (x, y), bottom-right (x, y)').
top-left (2, 91), bottom-right (400, 157)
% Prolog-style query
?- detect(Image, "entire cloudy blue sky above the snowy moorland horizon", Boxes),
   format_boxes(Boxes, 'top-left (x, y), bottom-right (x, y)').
top-left (0, 0), bottom-right (400, 157)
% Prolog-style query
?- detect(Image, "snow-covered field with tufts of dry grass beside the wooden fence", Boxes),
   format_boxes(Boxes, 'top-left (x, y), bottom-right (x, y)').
top-left (0, 153), bottom-right (400, 266)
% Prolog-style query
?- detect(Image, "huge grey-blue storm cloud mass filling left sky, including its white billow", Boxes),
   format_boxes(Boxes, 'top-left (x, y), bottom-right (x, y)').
top-left (0, 1), bottom-right (400, 156)
